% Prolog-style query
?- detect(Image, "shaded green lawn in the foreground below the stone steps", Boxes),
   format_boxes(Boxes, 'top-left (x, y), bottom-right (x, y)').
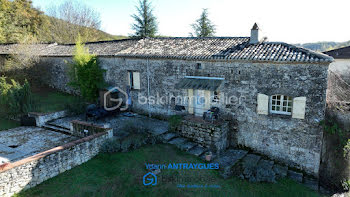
top-left (17, 145), bottom-right (319, 197)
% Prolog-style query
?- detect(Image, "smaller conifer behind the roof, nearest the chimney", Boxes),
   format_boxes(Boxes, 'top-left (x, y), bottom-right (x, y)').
top-left (190, 9), bottom-right (216, 37)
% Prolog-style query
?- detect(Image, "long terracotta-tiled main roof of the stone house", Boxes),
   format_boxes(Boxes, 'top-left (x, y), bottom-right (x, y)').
top-left (0, 37), bottom-right (333, 62)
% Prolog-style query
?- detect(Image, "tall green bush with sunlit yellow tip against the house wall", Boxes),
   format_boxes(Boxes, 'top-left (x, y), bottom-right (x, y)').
top-left (69, 37), bottom-right (105, 102)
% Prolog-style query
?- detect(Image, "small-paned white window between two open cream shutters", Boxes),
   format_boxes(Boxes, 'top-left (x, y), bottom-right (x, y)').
top-left (270, 94), bottom-right (293, 115)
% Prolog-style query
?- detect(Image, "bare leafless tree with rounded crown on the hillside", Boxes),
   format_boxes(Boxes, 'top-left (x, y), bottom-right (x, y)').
top-left (48, 0), bottom-right (101, 43)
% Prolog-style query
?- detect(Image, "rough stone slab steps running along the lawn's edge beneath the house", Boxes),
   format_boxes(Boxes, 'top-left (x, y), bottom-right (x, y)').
top-left (162, 132), bottom-right (319, 190)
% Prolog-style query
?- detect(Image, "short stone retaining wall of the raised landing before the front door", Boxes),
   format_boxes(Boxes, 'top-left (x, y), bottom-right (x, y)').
top-left (178, 119), bottom-right (229, 152)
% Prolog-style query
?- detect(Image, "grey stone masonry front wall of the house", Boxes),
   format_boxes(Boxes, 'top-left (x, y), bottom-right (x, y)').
top-left (31, 57), bottom-right (328, 176)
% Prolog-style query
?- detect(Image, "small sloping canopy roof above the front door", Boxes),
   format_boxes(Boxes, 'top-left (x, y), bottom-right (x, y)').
top-left (175, 77), bottom-right (223, 91)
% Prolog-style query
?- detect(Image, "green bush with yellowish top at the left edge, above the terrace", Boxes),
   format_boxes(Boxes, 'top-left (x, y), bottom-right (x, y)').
top-left (0, 77), bottom-right (35, 117)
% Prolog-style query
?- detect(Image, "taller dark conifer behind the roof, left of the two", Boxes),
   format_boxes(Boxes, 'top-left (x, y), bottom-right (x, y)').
top-left (131, 0), bottom-right (158, 38)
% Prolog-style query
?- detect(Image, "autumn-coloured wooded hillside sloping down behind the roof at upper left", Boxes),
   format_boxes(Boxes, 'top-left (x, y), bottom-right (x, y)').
top-left (0, 0), bottom-right (125, 43)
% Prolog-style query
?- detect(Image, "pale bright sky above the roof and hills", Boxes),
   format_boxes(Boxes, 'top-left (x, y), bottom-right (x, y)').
top-left (33, 0), bottom-right (350, 43)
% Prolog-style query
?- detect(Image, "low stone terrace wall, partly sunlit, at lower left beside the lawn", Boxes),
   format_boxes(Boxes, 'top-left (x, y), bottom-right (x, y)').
top-left (0, 132), bottom-right (108, 197)
